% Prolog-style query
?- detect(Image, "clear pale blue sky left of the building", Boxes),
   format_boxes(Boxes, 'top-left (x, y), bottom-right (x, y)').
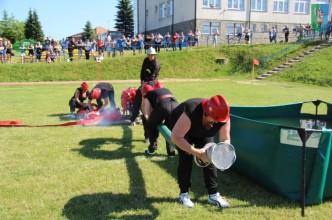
top-left (0, 0), bottom-right (118, 40)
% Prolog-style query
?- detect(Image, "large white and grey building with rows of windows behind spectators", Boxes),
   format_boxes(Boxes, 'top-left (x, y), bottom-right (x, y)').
top-left (135, 0), bottom-right (332, 43)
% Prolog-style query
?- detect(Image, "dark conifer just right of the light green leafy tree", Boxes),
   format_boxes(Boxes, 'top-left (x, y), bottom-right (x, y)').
top-left (24, 9), bottom-right (44, 41)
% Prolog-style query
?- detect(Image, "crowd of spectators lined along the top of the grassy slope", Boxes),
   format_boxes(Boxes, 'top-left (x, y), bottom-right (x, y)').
top-left (0, 24), bottom-right (332, 63)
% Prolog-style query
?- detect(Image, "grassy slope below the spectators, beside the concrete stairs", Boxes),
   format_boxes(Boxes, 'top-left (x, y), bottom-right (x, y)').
top-left (0, 42), bottom-right (332, 86)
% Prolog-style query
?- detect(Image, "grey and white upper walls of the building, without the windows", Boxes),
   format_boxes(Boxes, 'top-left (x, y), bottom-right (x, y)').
top-left (137, 0), bottom-right (332, 37)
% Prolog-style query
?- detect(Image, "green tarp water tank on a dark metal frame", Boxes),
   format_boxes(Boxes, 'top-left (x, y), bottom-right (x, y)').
top-left (231, 102), bottom-right (332, 205)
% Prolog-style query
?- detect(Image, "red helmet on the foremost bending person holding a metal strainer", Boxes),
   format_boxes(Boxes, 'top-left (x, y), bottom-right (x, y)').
top-left (202, 95), bottom-right (230, 122)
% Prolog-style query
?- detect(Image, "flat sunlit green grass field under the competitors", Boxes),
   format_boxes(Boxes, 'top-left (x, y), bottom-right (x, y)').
top-left (0, 78), bottom-right (332, 220)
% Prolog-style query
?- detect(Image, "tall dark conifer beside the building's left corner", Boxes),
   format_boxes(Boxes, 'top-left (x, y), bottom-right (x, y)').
top-left (115, 0), bottom-right (134, 37)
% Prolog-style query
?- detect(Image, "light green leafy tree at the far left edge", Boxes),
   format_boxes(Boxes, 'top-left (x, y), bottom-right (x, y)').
top-left (0, 10), bottom-right (24, 43)
